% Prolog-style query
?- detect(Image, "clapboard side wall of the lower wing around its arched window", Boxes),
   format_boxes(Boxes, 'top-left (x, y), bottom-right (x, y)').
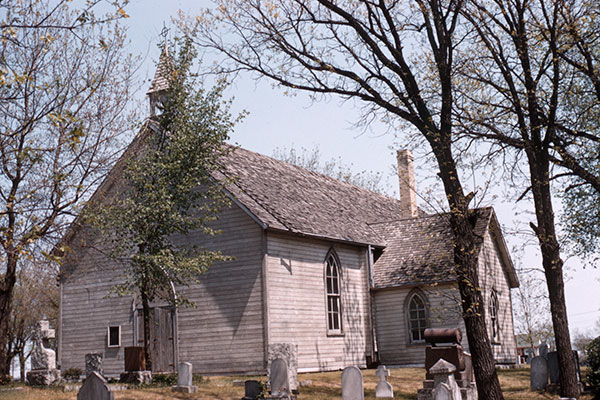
top-left (373, 285), bottom-right (468, 365)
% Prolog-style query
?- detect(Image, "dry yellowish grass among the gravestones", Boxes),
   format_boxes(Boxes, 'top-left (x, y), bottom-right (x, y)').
top-left (0, 368), bottom-right (592, 400)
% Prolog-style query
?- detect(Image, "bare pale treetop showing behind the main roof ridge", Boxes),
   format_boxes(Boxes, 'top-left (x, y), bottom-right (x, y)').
top-left (273, 146), bottom-right (386, 194)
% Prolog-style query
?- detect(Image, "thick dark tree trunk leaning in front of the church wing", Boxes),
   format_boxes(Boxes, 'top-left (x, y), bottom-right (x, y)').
top-left (430, 142), bottom-right (504, 400)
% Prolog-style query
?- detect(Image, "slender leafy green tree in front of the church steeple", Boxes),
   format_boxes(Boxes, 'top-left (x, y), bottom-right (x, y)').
top-left (87, 39), bottom-right (237, 369)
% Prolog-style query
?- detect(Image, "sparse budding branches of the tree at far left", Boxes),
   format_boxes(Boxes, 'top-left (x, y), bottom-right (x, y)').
top-left (0, 0), bottom-right (135, 378)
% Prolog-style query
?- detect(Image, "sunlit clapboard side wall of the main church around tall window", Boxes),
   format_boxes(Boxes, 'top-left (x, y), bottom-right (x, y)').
top-left (266, 232), bottom-right (372, 371)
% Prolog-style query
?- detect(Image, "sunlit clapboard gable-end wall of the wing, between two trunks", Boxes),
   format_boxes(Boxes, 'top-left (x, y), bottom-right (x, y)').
top-left (479, 227), bottom-right (517, 364)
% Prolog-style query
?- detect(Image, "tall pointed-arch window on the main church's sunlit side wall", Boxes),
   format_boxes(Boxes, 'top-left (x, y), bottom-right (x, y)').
top-left (324, 250), bottom-right (344, 335)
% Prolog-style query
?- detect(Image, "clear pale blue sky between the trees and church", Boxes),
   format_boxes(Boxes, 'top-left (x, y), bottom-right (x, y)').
top-left (125, 0), bottom-right (600, 334)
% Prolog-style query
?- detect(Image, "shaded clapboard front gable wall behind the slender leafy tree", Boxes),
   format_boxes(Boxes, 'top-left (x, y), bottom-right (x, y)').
top-left (60, 205), bottom-right (265, 375)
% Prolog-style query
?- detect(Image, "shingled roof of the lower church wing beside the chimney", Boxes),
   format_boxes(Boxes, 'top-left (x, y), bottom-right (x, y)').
top-left (370, 207), bottom-right (518, 289)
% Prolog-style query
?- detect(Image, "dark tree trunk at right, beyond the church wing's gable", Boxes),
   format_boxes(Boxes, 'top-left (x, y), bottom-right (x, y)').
top-left (527, 154), bottom-right (580, 398)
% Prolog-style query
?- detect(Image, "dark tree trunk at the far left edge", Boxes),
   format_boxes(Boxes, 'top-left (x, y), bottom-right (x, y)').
top-left (0, 255), bottom-right (17, 376)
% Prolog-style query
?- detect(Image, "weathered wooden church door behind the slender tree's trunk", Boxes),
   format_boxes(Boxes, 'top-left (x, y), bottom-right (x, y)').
top-left (138, 307), bottom-right (175, 372)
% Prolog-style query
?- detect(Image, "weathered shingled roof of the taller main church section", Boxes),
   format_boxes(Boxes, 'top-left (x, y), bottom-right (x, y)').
top-left (216, 147), bottom-right (400, 246)
